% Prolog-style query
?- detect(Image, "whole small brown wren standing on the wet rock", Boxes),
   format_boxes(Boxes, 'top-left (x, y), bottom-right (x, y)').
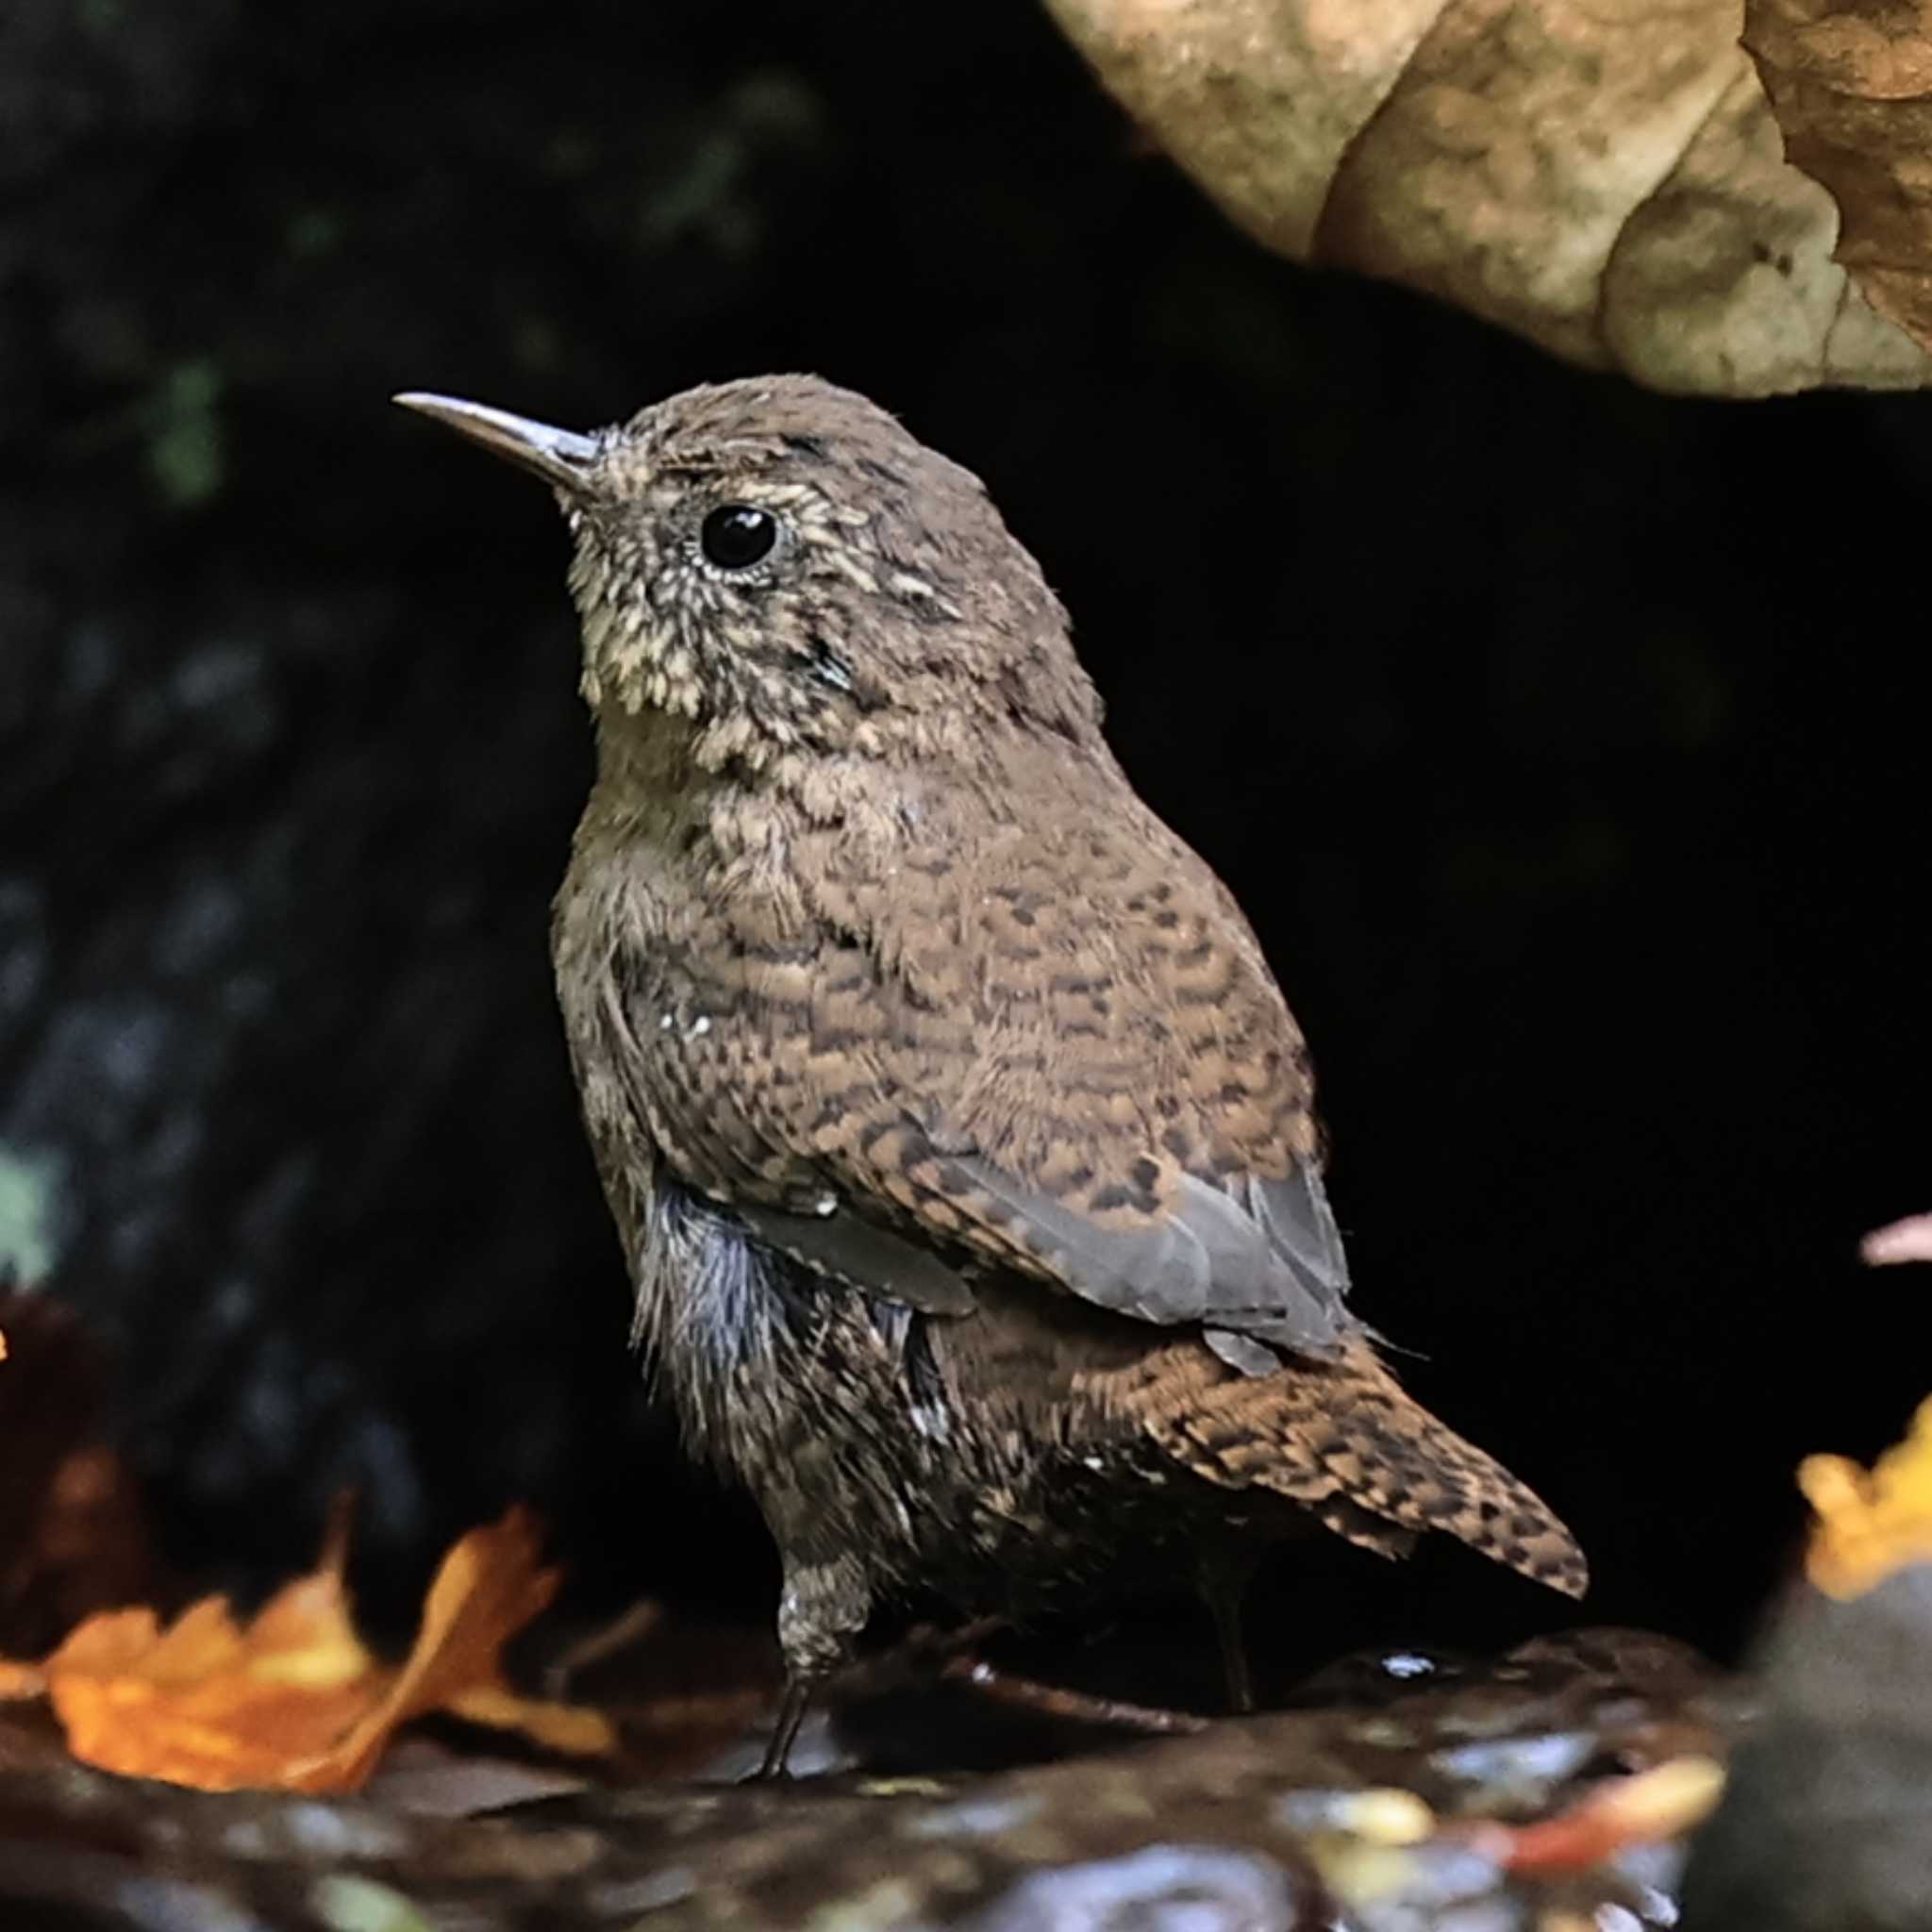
top-left (404, 376), bottom-right (1584, 1762)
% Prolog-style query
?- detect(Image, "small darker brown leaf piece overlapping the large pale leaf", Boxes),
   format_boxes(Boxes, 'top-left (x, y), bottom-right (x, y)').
top-left (1744, 0), bottom-right (1932, 348)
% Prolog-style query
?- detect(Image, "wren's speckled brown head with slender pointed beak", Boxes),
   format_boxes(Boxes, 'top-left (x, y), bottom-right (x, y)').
top-left (396, 375), bottom-right (1099, 767)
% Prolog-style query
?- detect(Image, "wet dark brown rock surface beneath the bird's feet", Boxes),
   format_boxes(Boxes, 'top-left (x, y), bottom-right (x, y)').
top-left (0, 1631), bottom-right (1740, 1932)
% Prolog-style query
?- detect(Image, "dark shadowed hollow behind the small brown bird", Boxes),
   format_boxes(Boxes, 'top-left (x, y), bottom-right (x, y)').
top-left (0, 0), bottom-right (1932, 1669)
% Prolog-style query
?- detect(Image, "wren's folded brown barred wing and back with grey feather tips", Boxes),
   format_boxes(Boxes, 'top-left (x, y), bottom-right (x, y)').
top-left (628, 799), bottom-right (1358, 1374)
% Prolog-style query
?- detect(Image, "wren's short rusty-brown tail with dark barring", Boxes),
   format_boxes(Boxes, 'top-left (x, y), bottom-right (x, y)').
top-left (1117, 1342), bottom-right (1591, 1596)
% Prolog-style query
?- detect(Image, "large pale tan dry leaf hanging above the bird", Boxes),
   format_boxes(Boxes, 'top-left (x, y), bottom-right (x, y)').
top-left (1047, 0), bottom-right (1932, 396)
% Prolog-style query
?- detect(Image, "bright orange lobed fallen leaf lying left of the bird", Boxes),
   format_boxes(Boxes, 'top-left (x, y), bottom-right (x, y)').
top-left (0, 1508), bottom-right (616, 1790)
